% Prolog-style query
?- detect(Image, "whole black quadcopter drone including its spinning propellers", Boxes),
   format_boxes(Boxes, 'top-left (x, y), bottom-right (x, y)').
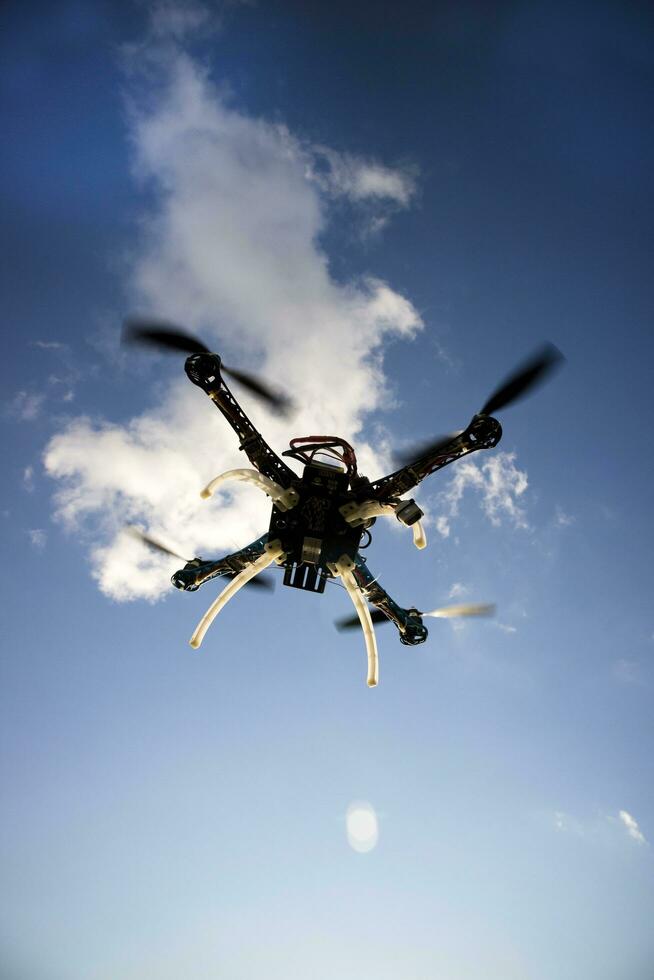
top-left (123, 318), bottom-right (563, 687)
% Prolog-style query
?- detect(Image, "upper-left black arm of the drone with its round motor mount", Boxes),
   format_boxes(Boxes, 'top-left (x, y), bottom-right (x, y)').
top-left (184, 354), bottom-right (298, 489)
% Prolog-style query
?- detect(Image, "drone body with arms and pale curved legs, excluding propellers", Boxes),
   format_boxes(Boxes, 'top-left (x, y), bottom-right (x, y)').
top-left (172, 352), bottom-right (502, 687)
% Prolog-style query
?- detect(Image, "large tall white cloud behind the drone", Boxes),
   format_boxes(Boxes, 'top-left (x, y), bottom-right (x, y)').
top-left (44, 27), bottom-right (421, 599)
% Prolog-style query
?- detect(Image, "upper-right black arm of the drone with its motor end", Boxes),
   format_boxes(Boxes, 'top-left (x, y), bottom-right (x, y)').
top-left (366, 415), bottom-right (502, 501)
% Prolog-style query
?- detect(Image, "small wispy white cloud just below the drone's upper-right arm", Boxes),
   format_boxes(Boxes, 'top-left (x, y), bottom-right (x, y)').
top-left (436, 452), bottom-right (529, 537)
